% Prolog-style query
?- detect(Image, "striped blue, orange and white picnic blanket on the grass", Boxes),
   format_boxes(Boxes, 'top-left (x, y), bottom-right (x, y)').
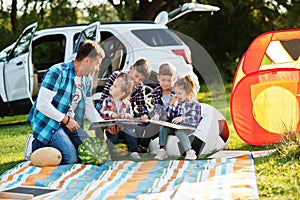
top-left (0, 154), bottom-right (259, 200)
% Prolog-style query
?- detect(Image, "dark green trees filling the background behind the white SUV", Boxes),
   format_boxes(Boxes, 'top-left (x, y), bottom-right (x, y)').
top-left (0, 0), bottom-right (300, 82)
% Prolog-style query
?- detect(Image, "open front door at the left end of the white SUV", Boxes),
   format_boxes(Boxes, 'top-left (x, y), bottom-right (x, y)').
top-left (3, 22), bottom-right (38, 102)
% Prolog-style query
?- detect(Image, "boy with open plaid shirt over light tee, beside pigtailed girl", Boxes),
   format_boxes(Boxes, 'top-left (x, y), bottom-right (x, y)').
top-left (138, 62), bottom-right (176, 151)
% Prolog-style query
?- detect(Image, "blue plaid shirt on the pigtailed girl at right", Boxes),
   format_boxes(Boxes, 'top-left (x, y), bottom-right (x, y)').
top-left (166, 100), bottom-right (202, 128)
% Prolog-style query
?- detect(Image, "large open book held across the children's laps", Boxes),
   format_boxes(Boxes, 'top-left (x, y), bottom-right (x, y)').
top-left (89, 119), bottom-right (196, 131)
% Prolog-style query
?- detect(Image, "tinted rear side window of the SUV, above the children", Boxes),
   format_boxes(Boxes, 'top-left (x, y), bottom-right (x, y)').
top-left (131, 29), bottom-right (182, 47)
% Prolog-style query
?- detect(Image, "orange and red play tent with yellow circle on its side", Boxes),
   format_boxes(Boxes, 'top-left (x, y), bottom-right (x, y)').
top-left (230, 29), bottom-right (300, 145)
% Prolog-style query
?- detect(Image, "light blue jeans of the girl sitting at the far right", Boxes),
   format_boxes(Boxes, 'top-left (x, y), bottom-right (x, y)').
top-left (159, 127), bottom-right (192, 151)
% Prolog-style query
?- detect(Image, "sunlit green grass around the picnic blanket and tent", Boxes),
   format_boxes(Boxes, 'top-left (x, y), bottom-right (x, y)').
top-left (0, 90), bottom-right (300, 200)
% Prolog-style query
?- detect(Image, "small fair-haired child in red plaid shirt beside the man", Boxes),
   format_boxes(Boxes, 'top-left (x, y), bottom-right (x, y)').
top-left (100, 72), bottom-right (141, 159)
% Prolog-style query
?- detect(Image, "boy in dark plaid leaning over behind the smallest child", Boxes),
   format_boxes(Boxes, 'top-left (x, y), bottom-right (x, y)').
top-left (96, 58), bottom-right (151, 120)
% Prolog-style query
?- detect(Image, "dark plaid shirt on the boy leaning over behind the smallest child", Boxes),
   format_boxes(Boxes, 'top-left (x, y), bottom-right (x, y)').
top-left (96, 71), bottom-right (148, 116)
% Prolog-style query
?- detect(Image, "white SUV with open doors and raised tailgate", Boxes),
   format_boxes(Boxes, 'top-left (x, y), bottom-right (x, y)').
top-left (0, 4), bottom-right (219, 117)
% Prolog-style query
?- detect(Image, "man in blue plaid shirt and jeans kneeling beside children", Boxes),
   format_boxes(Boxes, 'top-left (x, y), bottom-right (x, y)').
top-left (28, 40), bottom-right (104, 164)
